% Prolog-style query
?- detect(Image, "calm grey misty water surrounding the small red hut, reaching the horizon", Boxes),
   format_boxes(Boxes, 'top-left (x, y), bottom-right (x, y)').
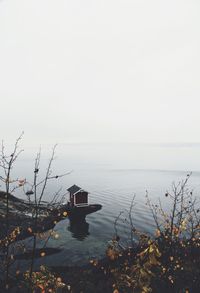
top-left (13, 144), bottom-right (200, 265)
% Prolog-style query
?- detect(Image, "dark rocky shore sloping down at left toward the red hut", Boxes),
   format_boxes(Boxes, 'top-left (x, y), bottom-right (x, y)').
top-left (0, 191), bottom-right (67, 241)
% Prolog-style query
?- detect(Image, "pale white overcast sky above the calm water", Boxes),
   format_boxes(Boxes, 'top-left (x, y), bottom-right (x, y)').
top-left (0, 0), bottom-right (200, 145)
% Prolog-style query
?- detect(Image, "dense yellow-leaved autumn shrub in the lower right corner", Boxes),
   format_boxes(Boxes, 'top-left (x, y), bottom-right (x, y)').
top-left (104, 175), bottom-right (200, 293)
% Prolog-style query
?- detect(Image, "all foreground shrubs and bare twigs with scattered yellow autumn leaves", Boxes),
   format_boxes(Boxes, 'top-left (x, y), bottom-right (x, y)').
top-left (0, 137), bottom-right (200, 293)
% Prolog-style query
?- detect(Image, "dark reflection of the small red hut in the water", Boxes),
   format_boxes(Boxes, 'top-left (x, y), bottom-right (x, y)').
top-left (68, 217), bottom-right (90, 241)
